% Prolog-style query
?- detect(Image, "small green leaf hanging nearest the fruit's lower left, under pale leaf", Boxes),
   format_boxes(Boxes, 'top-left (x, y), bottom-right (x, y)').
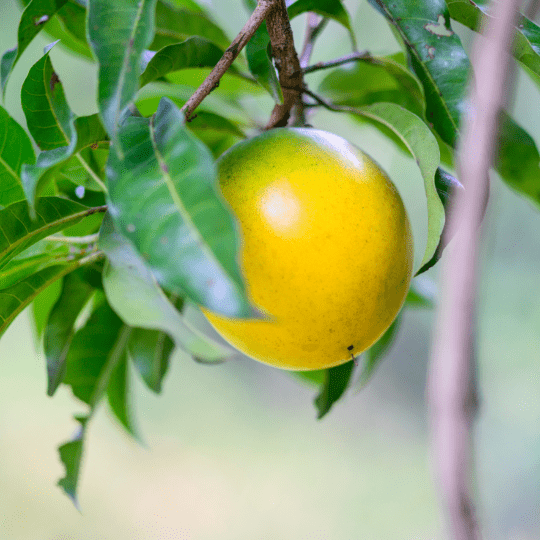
top-left (127, 328), bottom-right (174, 393)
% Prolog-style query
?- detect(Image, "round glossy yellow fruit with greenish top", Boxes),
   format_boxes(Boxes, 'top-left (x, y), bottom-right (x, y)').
top-left (202, 128), bottom-right (413, 370)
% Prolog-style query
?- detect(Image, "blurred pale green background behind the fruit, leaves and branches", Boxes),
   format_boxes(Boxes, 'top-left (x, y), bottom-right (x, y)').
top-left (0, 0), bottom-right (540, 540)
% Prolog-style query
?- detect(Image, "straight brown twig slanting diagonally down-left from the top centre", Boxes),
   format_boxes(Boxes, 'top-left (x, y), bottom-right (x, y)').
top-left (181, 0), bottom-right (279, 121)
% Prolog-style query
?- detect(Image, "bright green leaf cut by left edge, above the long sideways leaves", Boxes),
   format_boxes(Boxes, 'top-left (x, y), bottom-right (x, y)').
top-left (0, 107), bottom-right (36, 209)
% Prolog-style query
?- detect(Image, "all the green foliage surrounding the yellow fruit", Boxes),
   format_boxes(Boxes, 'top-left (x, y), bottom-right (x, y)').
top-left (0, 0), bottom-right (540, 501)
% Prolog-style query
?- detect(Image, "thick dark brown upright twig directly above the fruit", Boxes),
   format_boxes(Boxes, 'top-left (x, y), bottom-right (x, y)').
top-left (265, 0), bottom-right (304, 129)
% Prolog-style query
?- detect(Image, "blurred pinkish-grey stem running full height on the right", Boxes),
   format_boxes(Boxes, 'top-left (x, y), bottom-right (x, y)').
top-left (427, 0), bottom-right (520, 540)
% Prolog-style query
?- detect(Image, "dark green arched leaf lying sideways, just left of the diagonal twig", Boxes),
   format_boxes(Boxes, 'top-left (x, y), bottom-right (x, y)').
top-left (140, 37), bottom-right (227, 86)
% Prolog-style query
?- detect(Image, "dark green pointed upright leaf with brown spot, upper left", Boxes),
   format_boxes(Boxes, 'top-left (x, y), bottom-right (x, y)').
top-left (21, 42), bottom-right (74, 150)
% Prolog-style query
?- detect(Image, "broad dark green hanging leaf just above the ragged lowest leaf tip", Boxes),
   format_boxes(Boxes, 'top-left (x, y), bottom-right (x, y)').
top-left (63, 302), bottom-right (126, 409)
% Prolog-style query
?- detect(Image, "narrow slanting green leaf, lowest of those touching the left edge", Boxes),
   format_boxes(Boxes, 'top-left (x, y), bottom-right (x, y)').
top-left (0, 260), bottom-right (100, 336)
